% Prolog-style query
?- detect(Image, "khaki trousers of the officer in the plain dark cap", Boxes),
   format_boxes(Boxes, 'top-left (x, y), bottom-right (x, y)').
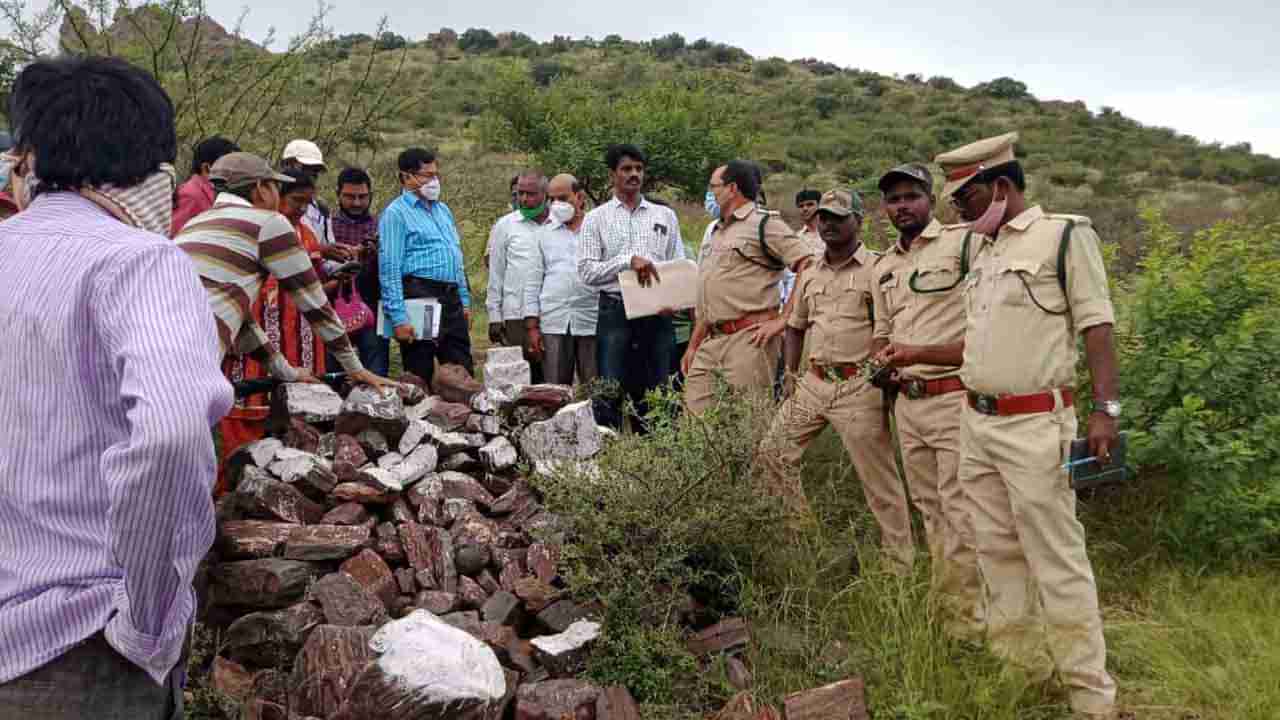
top-left (895, 392), bottom-right (986, 641)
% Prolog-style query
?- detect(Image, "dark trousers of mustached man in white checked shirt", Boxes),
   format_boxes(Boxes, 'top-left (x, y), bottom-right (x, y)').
top-left (593, 292), bottom-right (676, 430)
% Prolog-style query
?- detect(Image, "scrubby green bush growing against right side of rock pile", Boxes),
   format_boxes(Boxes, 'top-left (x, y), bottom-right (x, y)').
top-left (536, 389), bottom-right (781, 705)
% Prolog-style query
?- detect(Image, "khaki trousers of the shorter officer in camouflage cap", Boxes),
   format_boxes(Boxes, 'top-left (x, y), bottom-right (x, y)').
top-left (762, 372), bottom-right (914, 573)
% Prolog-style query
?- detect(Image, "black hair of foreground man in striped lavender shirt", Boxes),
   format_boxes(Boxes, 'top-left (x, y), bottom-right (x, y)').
top-left (9, 56), bottom-right (178, 191)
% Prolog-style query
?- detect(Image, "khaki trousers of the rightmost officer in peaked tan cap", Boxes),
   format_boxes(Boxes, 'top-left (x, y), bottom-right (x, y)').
top-left (960, 406), bottom-right (1116, 714)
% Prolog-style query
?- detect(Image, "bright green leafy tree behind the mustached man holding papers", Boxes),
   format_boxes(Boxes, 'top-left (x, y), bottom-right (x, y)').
top-left (483, 67), bottom-right (750, 202)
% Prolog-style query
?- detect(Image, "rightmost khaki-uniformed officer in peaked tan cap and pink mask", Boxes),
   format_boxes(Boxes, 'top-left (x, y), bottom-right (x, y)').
top-left (937, 133), bottom-right (1120, 717)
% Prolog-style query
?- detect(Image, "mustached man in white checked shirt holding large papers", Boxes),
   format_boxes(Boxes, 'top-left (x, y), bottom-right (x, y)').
top-left (577, 145), bottom-right (685, 430)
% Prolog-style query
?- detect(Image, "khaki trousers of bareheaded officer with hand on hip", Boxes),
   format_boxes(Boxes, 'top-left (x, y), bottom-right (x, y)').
top-left (685, 328), bottom-right (782, 415)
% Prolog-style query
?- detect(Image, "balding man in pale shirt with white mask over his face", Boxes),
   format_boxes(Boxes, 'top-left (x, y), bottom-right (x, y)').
top-left (525, 174), bottom-right (599, 386)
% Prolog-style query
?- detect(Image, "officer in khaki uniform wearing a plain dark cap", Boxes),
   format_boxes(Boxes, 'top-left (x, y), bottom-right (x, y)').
top-left (872, 163), bottom-right (984, 641)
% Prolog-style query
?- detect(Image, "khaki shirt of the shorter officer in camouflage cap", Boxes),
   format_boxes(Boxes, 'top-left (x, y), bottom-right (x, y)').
top-left (787, 245), bottom-right (879, 365)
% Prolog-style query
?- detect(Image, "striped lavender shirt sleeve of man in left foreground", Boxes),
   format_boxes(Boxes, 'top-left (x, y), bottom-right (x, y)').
top-left (97, 246), bottom-right (233, 683)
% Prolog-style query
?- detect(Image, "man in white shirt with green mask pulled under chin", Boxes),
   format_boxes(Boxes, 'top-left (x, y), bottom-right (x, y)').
top-left (485, 170), bottom-right (548, 383)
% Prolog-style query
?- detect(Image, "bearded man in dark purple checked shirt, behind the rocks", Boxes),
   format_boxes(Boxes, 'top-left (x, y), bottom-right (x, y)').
top-left (325, 168), bottom-right (390, 377)
